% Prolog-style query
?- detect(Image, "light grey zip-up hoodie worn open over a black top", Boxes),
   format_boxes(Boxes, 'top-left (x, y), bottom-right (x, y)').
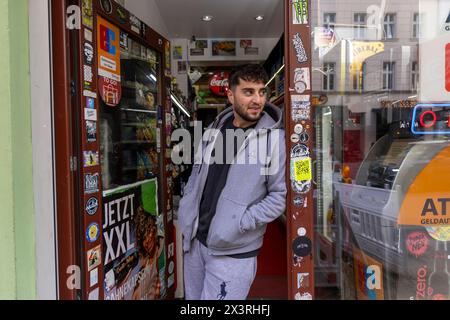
top-left (178, 103), bottom-right (286, 255)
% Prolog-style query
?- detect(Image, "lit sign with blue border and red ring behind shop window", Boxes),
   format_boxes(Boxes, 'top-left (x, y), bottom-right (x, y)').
top-left (411, 103), bottom-right (450, 134)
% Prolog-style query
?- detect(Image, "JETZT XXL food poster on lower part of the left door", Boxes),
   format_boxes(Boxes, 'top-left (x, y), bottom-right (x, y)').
top-left (102, 179), bottom-right (166, 300)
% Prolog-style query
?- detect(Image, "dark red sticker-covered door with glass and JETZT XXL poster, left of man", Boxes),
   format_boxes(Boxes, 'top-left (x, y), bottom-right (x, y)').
top-left (52, 0), bottom-right (176, 300)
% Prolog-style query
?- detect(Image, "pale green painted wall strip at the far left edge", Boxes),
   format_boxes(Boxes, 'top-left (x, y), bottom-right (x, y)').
top-left (0, 0), bottom-right (36, 299)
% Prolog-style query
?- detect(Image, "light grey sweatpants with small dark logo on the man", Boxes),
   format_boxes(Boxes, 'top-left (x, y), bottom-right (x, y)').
top-left (184, 239), bottom-right (257, 300)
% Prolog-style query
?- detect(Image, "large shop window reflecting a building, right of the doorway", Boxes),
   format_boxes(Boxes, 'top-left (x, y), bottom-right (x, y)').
top-left (311, 0), bottom-right (450, 300)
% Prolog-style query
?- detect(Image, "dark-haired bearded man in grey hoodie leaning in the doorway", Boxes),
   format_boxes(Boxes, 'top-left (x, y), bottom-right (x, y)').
top-left (178, 64), bottom-right (286, 300)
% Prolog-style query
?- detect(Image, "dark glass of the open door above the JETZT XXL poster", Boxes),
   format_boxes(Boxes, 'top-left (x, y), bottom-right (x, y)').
top-left (100, 32), bottom-right (160, 190)
